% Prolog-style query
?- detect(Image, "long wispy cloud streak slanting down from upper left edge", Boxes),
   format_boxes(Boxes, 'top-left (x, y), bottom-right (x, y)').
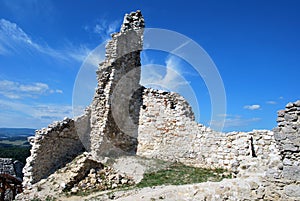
top-left (0, 19), bottom-right (90, 61)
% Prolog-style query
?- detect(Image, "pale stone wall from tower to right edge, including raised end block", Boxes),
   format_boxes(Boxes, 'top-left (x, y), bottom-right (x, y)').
top-left (137, 96), bottom-right (300, 201)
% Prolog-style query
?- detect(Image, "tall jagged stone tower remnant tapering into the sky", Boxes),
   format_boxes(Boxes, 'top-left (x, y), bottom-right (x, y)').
top-left (91, 11), bottom-right (144, 159)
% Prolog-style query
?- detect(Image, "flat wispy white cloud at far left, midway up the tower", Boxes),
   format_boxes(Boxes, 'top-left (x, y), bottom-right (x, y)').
top-left (0, 80), bottom-right (63, 99)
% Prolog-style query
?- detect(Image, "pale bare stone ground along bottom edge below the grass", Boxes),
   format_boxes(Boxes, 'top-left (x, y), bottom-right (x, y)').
top-left (90, 178), bottom-right (262, 201)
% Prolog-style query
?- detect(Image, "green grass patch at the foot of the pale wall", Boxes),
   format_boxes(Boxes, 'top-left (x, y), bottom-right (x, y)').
top-left (137, 163), bottom-right (231, 188)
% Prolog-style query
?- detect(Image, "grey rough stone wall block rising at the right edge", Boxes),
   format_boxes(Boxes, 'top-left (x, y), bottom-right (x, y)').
top-left (265, 100), bottom-right (300, 200)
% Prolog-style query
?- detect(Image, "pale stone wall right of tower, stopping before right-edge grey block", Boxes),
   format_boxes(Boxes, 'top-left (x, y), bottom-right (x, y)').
top-left (137, 89), bottom-right (276, 173)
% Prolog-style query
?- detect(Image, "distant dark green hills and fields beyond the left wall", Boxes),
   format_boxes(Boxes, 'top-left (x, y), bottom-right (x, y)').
top-left (0, 128), bottom-right (35, 164)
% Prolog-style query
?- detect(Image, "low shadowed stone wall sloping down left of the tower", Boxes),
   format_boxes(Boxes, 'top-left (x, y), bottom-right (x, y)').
top-left (23, 118), bottom-right (84, 187)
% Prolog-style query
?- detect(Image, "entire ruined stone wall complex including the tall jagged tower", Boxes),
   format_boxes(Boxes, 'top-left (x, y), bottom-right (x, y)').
top-left (24, 11), bottom-right (300, 200)
